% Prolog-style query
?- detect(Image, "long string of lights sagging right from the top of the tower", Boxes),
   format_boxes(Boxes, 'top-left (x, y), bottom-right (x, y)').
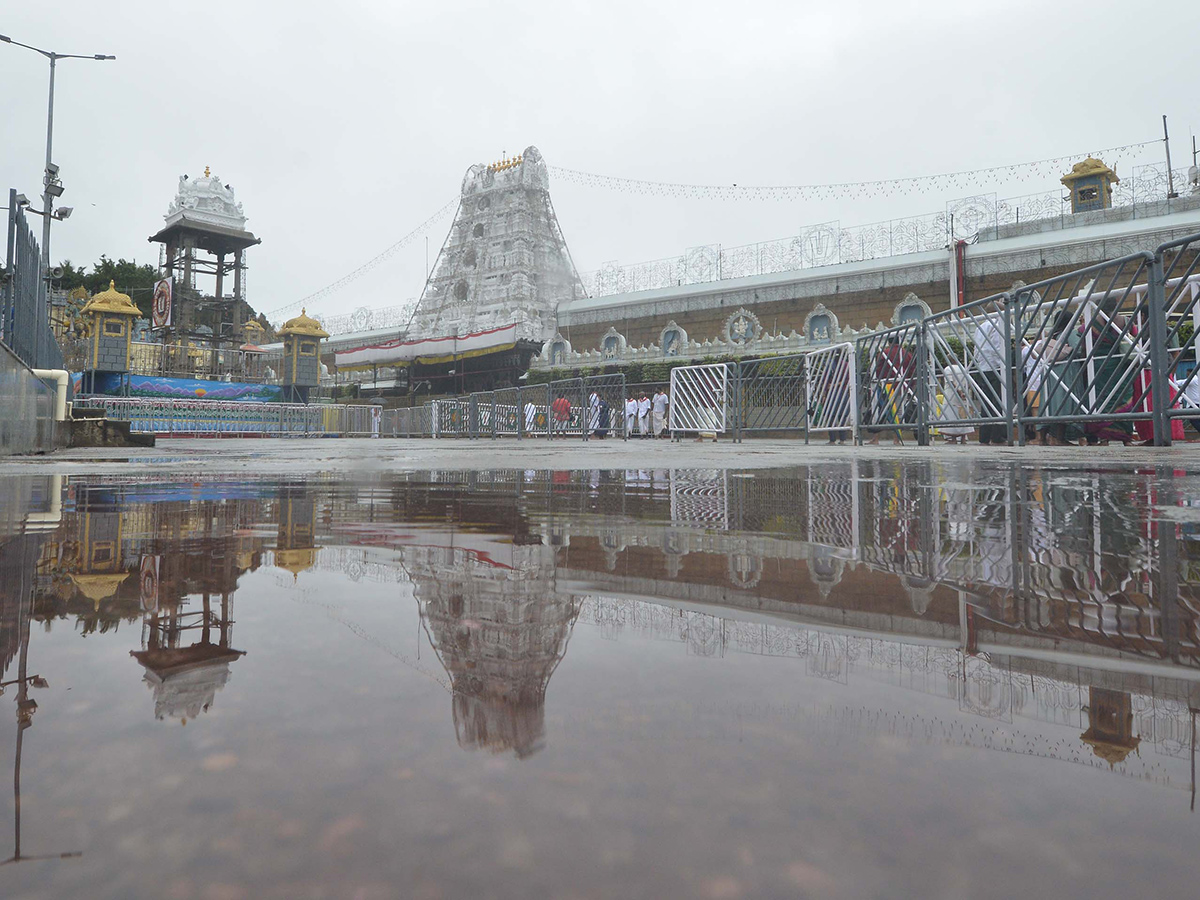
top-left (550, 139), bottom-right (1162, 202)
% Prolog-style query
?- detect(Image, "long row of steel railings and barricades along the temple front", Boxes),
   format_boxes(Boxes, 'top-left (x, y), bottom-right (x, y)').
top-left (68, 234), bottom-right (1200, 445)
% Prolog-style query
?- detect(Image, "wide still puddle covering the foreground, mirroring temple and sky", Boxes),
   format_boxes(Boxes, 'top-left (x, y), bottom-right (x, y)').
top-left (0, 458), bottom-right (1200, 900)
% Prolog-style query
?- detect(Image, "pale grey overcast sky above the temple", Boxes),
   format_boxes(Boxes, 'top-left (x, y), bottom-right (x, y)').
top-left (0, 0), bottom-right (1200, 324)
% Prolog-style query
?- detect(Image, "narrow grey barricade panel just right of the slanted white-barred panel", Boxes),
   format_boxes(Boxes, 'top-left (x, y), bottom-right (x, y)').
top-left (854, 322), bottom-right (925, 443)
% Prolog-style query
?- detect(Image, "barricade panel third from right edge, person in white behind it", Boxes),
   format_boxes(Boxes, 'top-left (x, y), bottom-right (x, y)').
top-left (922, 294), bottom-right (1015, 444)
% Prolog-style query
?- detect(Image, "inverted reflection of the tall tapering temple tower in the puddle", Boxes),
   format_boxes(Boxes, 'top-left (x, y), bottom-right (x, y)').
top-left (413, 538), bottom-right (580, 758)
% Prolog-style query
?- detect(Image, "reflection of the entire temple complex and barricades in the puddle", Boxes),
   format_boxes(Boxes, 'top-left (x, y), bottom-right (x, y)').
top-left (7, 461), bottom-right (1200, 784)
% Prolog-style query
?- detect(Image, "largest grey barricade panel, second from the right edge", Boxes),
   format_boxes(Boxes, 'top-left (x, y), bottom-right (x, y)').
top-left (1013, 253), bottom-right (1166, 443)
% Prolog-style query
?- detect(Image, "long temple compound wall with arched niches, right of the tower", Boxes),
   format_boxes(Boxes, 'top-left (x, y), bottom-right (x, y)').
top-left (534, 196), bottom-right (1200, 368)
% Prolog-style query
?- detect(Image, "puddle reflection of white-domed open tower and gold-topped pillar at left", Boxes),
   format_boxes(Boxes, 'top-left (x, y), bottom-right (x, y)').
top-left (18, 479), bottom-right (272, 719)
